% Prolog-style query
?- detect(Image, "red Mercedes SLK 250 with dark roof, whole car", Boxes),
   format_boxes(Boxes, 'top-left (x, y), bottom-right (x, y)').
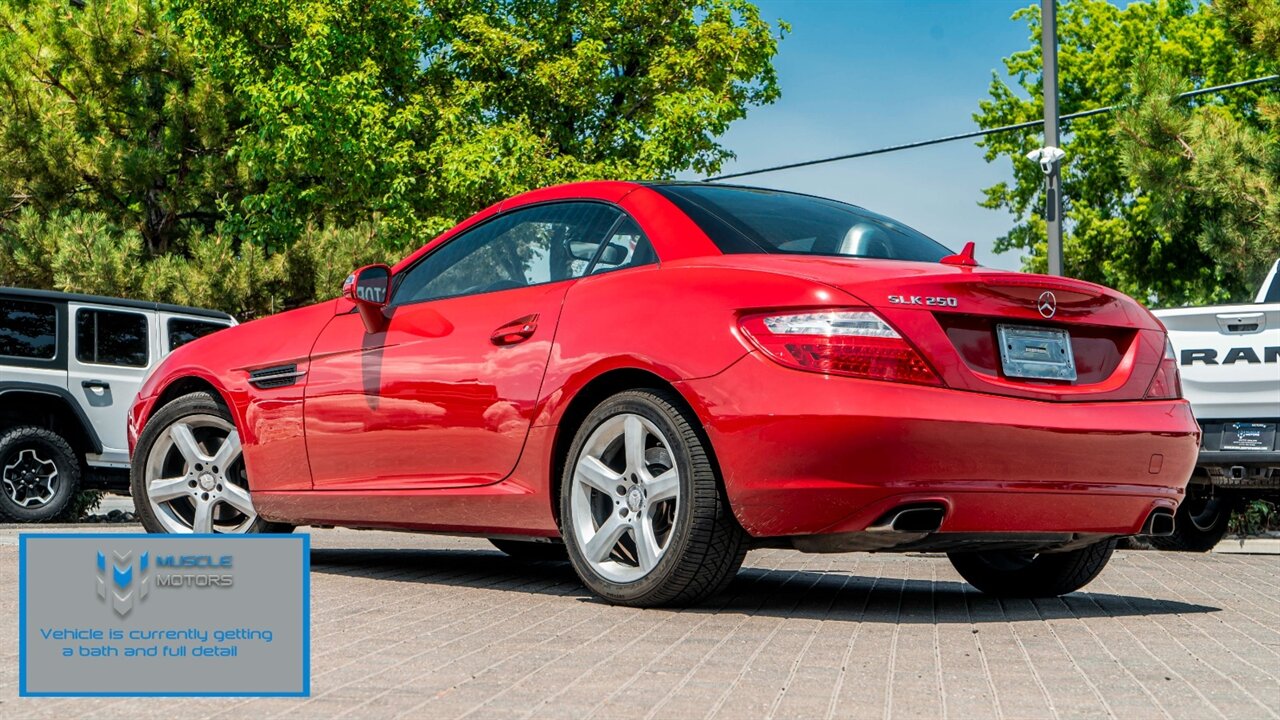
top-left (129, 182), bottom-right (1199, 606)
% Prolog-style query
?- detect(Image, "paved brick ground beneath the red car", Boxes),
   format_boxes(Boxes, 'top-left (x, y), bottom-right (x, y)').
top-left (0, 530), bottom-right (1280, 720)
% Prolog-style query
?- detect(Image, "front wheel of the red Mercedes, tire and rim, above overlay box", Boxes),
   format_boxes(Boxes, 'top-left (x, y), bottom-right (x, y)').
top-left (129, 392), bottom-right (293, 534)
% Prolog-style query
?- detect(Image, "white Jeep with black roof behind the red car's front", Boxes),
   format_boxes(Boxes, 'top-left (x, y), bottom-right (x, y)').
top-left (0, 287), bottom-right (236, 523)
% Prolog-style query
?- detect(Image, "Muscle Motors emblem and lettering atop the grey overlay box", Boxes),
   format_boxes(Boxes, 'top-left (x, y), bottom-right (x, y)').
top-left (97, 550), bottom-right (234, 618)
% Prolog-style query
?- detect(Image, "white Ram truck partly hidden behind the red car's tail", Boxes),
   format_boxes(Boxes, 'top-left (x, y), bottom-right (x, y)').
top-left (1151, 260), bottom-right (1280, 552)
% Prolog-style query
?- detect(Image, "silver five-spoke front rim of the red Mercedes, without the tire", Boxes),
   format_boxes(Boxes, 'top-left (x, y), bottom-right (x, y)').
top-left (146, 414), bottom-right (257, 533)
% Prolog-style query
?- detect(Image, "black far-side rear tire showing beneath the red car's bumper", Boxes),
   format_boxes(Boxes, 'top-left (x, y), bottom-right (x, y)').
top-left (947, 538), bottom-right (1116, 597)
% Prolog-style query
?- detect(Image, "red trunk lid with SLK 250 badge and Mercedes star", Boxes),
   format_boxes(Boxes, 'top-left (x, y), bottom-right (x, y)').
top-left (701, 255), bottom-right (1165, 402)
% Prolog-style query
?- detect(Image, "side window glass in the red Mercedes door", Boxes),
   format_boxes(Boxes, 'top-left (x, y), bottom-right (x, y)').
top-left (392, 202), bottom-right (621, 305)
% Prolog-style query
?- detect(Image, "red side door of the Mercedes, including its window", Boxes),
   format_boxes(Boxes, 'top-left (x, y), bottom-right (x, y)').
top-left (303, 202), bottom-right (623, 489)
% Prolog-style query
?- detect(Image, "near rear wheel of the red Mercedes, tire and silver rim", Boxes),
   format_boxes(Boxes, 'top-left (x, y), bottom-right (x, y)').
top-left (561, 389), bottom-right (749, 607)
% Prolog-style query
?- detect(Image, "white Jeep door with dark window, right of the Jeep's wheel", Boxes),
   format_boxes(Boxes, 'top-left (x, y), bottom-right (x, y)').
top-left (67, 302), bottom-right (157, 468)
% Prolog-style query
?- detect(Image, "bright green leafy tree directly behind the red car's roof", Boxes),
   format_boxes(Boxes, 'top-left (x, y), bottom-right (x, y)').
top-left (179, 0), bottom-right (778, 245)
